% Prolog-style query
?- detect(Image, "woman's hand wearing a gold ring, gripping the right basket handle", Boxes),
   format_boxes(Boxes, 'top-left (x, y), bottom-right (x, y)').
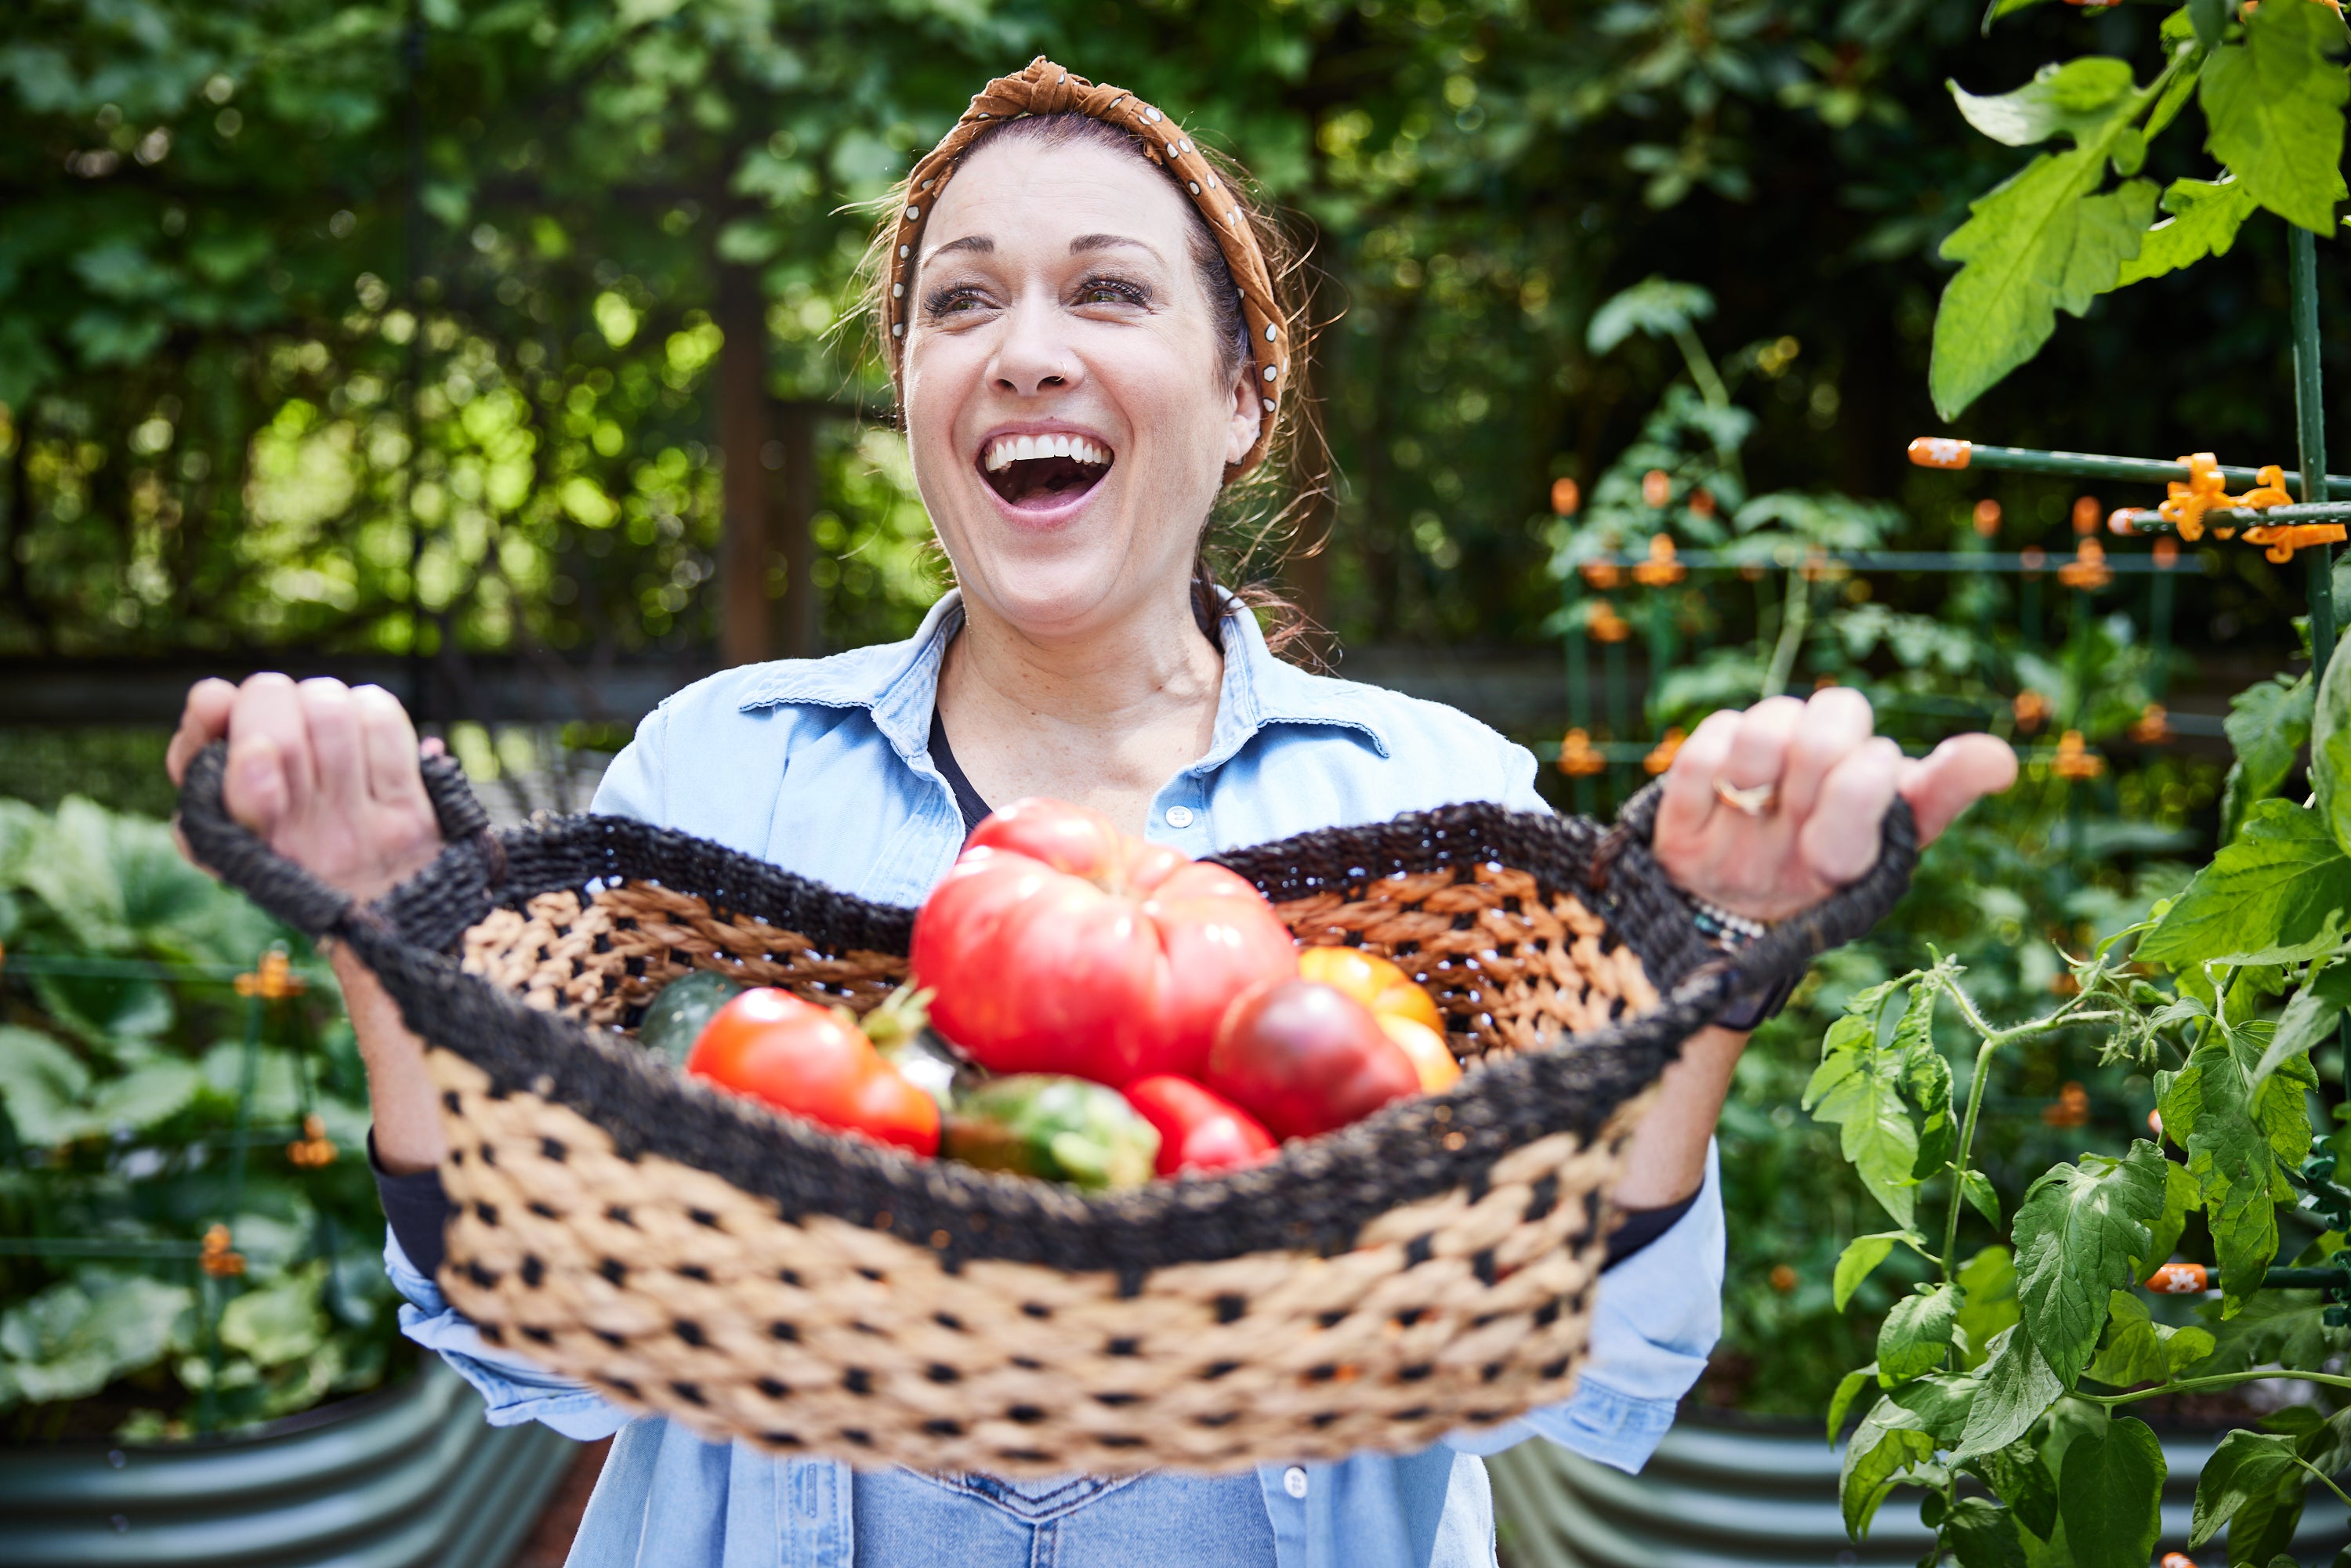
top-left (1655, 686), bottom-right (2017, 922)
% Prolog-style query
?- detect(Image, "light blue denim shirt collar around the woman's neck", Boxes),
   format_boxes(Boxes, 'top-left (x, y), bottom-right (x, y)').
top-left (741, 588), bottom-right (1389, 773)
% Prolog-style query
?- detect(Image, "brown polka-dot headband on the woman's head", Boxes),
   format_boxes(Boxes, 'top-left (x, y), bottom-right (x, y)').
top-left (889, 54), bottom-right (1291, 477)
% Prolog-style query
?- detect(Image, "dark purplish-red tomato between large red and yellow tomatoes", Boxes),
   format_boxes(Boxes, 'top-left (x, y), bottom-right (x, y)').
top-left (1208, 980), bottom-right (1420, 1138)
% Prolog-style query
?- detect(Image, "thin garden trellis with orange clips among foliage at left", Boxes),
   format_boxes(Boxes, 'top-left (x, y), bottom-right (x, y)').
top-left (0, 943), bottom-right (336, 1432)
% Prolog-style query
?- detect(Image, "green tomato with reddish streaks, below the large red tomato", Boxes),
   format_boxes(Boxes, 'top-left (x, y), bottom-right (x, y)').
top-left (938, 1072), bottom-right (1159, 1190)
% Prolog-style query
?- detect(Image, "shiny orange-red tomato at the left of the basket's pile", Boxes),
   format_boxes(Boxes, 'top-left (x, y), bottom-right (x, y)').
top-left (686, 985), bottom-right (938, 1154)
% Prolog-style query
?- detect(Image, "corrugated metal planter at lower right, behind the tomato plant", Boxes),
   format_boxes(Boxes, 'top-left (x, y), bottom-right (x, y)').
top-left (1486, 1413), bottom-right (2351, 1568)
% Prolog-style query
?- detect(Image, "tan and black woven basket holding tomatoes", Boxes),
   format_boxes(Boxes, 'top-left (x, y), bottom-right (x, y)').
top-left (181, 748), bottom-right (1916, 1474)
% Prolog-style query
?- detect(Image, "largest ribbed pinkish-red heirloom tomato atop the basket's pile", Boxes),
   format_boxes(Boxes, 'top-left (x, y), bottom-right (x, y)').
top-left (912, 799), bottom-right (1298, 1088)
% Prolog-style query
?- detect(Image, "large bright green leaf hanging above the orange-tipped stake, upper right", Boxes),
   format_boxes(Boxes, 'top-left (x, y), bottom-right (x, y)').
top-left (1928, 143), bottom-right (2156, 418)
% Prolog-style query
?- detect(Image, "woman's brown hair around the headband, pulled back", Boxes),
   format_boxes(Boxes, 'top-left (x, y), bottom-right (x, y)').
top-left (860, 66), bottom-right (1326, 656)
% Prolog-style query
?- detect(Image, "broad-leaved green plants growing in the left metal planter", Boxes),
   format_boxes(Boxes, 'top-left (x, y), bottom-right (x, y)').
top-left (0, 799), bottom-right (395, 1441)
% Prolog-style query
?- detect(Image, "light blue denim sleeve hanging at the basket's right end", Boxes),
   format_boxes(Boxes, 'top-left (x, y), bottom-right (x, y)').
top-left (1446, 1140), bottom-right (1726, 1472)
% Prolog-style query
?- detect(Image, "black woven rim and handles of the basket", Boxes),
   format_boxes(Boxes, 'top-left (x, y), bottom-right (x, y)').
top-left (181, 748), bottom-right (1916, 1288)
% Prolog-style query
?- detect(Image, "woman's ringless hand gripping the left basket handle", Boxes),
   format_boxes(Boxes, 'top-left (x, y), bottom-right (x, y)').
top-left (165, 675), bottom-right (442, 903)
